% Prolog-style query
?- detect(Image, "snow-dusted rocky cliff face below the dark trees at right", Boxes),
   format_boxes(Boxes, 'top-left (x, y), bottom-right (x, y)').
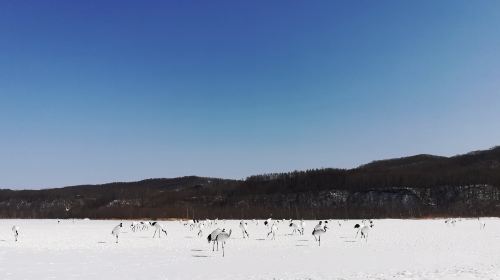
top-left (214, 185), bottom-right (500, 218)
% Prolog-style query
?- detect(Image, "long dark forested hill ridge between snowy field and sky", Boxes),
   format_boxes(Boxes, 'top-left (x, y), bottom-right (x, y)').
top-left (0, 147), bottom-right (500, 219)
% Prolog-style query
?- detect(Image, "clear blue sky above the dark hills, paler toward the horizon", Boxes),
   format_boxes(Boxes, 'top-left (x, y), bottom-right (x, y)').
top-left (0, 0), bottom-right (500, 188)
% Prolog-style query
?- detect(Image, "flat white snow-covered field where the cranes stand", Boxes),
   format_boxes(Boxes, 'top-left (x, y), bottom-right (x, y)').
top-left (0, 218), bottom-right (500, 280)
